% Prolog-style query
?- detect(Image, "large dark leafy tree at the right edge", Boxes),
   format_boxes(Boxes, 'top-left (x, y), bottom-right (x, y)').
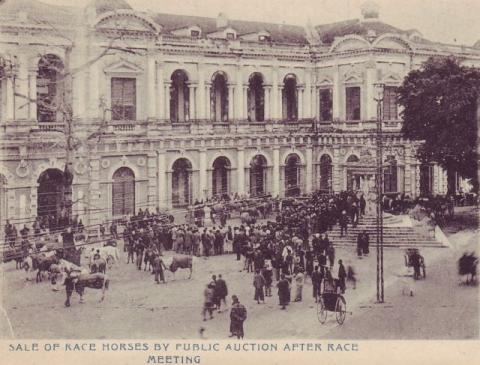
top-left (398, 57), bottom-right (480, 193)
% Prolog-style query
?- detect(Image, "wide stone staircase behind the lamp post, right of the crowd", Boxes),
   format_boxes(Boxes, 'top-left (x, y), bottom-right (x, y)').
top-left (328, 215), bottom-right (445, 247)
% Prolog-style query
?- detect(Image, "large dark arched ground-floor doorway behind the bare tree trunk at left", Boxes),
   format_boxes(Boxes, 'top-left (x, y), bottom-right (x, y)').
top-left (37, 169), bottom-right (68, 218)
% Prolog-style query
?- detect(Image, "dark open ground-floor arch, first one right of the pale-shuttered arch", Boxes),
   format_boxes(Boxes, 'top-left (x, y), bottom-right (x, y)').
top-left (172, 158), bottom-right (192, 207)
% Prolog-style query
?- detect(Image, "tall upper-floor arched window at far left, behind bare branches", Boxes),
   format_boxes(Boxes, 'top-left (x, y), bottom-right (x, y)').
top-left (37, 54), bottom-right (64, 123)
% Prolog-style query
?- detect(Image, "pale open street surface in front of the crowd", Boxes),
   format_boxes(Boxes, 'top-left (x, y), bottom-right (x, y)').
top-left (0, 208), bottom-right (479, 339)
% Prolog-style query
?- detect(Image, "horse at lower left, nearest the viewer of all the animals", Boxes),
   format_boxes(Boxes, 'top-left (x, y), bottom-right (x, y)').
top-left (65, 272), bottom-right (110, 307)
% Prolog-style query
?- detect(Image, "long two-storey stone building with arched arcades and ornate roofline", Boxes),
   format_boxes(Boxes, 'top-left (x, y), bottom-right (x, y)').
top-left (0, 0), bottom-right (480, 226)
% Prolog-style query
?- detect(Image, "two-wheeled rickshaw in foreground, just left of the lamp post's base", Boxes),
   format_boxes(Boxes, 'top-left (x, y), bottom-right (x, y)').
top-left (317, 274), bottom-right (347, 324)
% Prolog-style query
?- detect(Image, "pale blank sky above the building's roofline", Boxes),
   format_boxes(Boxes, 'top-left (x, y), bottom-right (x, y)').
top-left (40, 0), bottom-right (480, 46)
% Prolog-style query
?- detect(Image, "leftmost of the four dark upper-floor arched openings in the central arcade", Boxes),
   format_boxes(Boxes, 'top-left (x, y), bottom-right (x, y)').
top-left (170, 70), bottom-right (190, 123)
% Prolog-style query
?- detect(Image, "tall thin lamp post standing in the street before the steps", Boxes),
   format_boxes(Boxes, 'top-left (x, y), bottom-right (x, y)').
top-left (373, 83), bottom-right (385, 303)
